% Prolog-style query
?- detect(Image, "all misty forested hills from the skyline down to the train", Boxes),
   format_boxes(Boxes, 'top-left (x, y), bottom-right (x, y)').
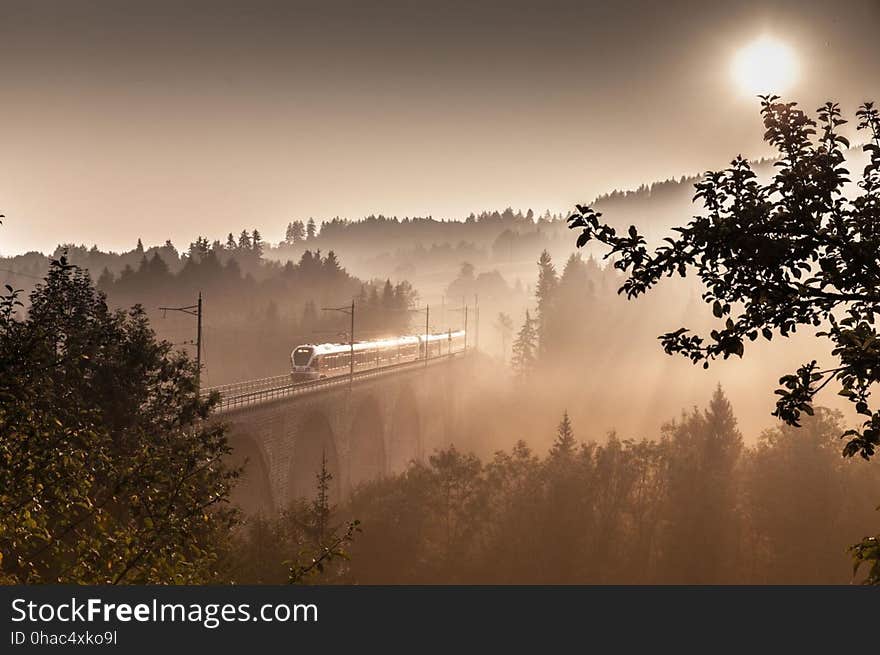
top-left (0, 152), bottom-right (820, 390)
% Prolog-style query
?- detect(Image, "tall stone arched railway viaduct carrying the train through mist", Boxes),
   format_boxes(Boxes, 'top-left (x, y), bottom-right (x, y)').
top-left (217, 353), bottom-right (473, 514)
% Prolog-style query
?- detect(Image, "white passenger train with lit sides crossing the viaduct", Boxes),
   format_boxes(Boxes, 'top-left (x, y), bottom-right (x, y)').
top-left (290, 330), bottom-right (466, 382)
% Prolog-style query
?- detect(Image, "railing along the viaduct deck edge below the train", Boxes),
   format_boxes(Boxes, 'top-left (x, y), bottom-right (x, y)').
top-left (202, 351), bottom-right (465, 412)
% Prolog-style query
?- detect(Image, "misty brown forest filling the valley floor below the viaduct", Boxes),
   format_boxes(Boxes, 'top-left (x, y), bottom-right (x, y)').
top-left (231, 389), bottom-right (880, 584)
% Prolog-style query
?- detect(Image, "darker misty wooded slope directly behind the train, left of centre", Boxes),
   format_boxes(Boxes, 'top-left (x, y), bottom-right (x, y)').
top-left (2, 229), bottom-right (417, 384)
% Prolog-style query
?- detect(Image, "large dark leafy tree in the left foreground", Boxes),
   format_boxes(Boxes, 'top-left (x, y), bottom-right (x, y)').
top-left (0, 257), bottom-right (236, 584)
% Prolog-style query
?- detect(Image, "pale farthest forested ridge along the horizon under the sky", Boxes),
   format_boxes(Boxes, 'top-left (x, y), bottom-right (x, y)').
top-left (0, 154), bottom-right (792, 286)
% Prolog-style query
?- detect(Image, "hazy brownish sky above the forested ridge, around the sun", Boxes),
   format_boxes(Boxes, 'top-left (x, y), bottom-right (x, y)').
top-left (0, 0), bottom-right (880, 254)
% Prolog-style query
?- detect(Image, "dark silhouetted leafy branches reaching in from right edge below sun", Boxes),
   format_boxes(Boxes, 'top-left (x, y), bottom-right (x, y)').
top-left (569, 96), bottom-right (880, 584)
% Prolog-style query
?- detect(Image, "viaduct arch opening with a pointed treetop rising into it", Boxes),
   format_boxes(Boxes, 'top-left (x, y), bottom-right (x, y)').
top-left (287, 411), bottom-right (340, 502)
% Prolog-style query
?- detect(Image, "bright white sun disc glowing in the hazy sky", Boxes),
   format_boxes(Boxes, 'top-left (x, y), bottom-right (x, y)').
top-left (732, 36), bottom-right (798, 95)
